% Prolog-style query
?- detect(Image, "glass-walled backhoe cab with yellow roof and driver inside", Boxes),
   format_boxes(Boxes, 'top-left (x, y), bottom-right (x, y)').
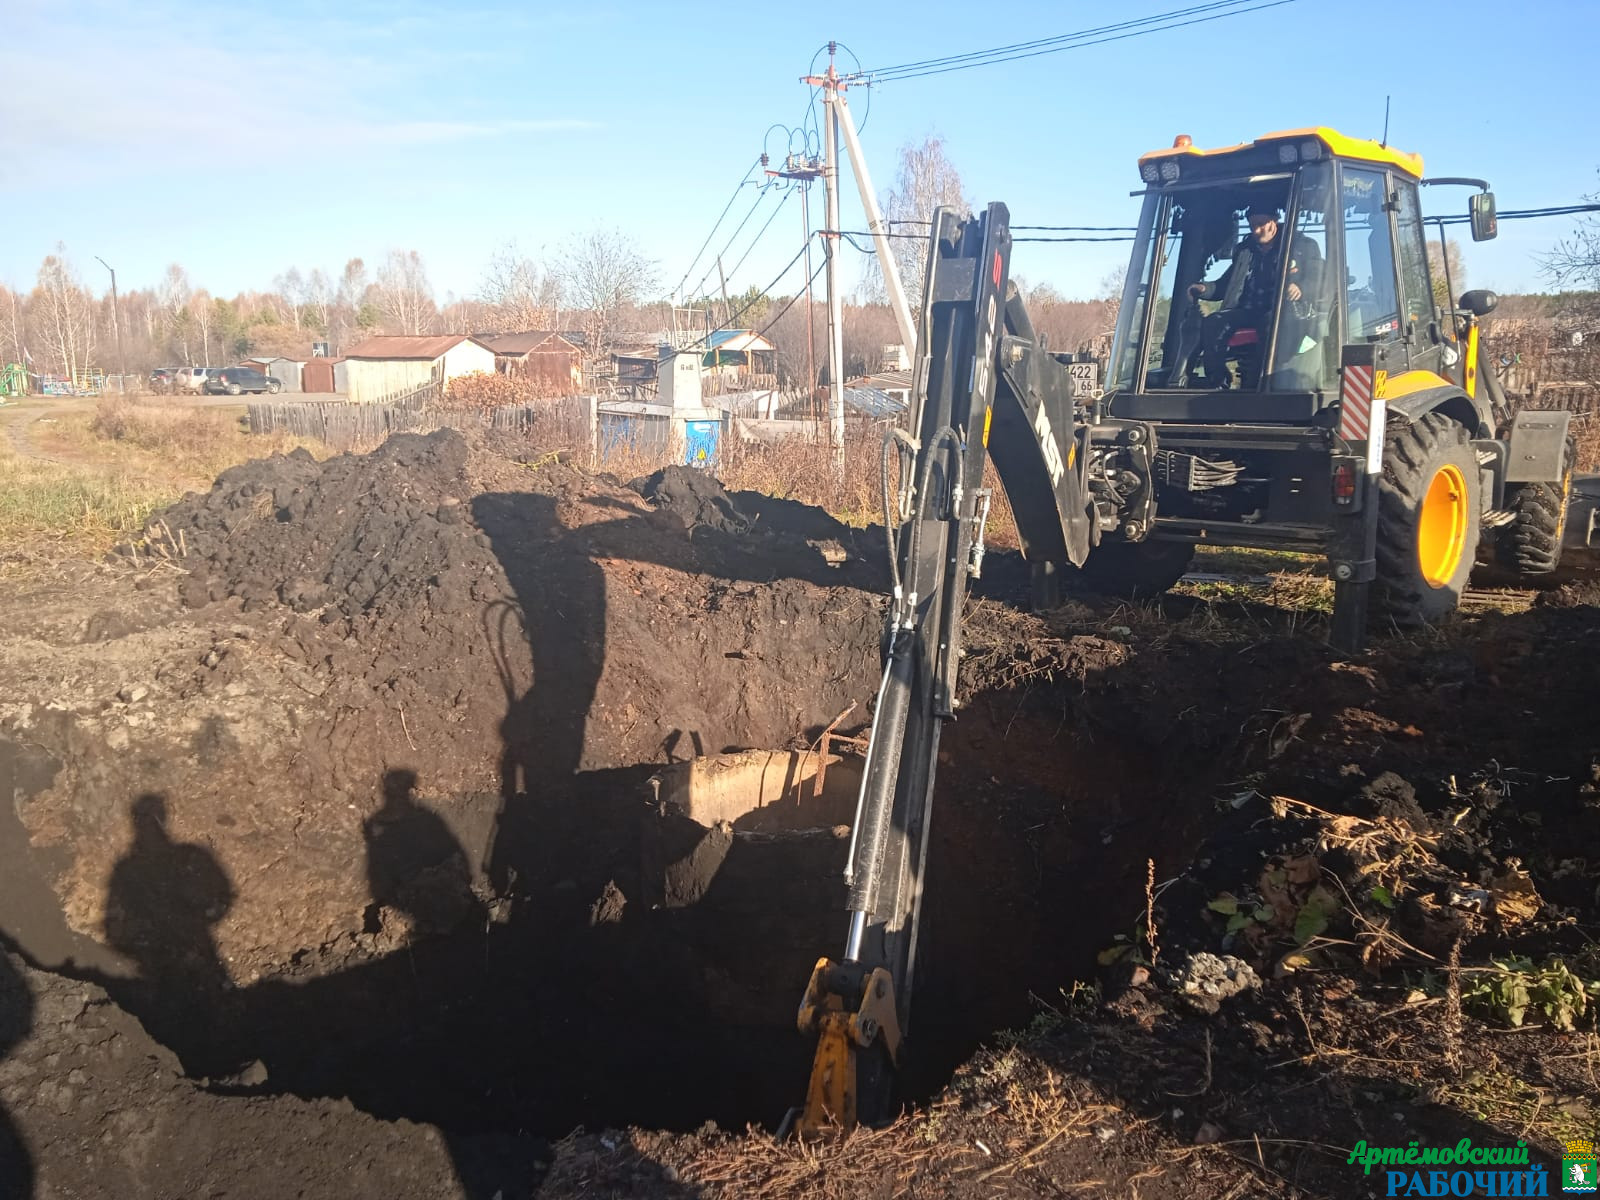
top-left (1107, 130), bottom-right (1453, 421)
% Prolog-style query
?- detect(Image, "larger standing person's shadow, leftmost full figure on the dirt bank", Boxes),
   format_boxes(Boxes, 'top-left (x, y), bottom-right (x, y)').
top-left (106, 794), bottom-right (235, 1075)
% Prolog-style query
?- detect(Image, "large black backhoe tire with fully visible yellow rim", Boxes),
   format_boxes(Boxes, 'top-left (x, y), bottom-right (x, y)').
top-left (1371, 411), bottom-right (1482, 629)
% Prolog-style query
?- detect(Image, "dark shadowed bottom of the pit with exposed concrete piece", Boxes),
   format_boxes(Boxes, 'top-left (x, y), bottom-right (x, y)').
top-left (6, 693), bottom-right (1203, 1138)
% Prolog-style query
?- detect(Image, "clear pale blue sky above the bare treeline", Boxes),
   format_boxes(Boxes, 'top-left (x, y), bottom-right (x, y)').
top-left (0, 0), bottom-right (1600, 299)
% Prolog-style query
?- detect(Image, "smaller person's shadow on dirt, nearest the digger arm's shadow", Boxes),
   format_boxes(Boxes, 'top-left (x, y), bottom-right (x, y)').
top-left (362, 771), bottom-right (480, 936)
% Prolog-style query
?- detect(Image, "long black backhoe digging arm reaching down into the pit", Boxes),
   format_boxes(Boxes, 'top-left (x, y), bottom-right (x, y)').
top-left (798, 203), bottom-right (1088, 1134)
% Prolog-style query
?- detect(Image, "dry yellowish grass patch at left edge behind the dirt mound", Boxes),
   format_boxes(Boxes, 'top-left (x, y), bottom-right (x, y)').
top-left (0, 398), bottom-right (318, 554)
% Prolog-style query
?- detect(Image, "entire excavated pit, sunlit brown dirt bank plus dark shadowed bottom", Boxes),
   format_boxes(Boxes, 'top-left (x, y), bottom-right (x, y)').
top-left (0, 434), bottom-right (1237, 1158)
